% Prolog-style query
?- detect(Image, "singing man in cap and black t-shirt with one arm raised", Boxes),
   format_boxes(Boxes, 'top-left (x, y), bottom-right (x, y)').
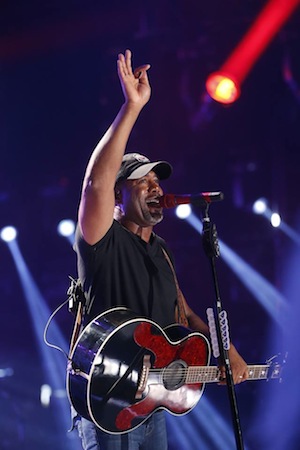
top-left (75, 50), bottom-right (247, 450)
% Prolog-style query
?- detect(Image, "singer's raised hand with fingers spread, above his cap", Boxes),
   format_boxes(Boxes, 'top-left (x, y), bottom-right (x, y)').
top-left (117, 50), bottom-right (151, 107)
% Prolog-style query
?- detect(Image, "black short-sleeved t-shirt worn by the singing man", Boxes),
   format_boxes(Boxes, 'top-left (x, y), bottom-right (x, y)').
top-left (75, 221), bottom-right (177, 327)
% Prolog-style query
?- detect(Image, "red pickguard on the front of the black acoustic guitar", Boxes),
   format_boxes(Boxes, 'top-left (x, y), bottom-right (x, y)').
top-left (115, 322), bottom-right (208, 431)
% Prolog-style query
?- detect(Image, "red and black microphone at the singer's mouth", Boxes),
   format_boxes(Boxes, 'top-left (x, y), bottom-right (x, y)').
top-left (159, 191), bottom-right (224, 208)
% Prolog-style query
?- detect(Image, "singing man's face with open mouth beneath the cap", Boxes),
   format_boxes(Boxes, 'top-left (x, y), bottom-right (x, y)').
top-left (122, 171), bottom-right (163, 227)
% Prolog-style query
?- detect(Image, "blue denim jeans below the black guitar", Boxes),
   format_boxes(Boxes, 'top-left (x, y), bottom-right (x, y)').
top-left (76, 411), bottom-right (168, 450)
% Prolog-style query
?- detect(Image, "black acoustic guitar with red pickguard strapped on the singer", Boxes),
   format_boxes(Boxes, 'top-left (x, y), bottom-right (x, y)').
top-left (67, 307), bottom-right (282, 434)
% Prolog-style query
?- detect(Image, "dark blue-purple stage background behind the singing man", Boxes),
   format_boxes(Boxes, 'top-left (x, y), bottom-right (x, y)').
top-left (0, 0), bottom-right (300, 450)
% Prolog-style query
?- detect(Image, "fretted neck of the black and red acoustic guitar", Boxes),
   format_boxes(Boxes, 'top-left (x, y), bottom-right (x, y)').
top-left (186, 364), bottom-right (280, 384)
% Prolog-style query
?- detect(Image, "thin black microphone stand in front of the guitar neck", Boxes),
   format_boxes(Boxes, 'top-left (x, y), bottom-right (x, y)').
top-left (202, 203), bottom-right (244, 450)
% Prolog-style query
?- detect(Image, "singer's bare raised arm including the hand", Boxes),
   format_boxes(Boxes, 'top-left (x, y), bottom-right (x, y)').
top-left (78, 50), bottom-right (151, 245)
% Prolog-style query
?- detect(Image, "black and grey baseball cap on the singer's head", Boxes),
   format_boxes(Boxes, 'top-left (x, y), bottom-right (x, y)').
top-left (116, 153), bottom-right (173, 181)
